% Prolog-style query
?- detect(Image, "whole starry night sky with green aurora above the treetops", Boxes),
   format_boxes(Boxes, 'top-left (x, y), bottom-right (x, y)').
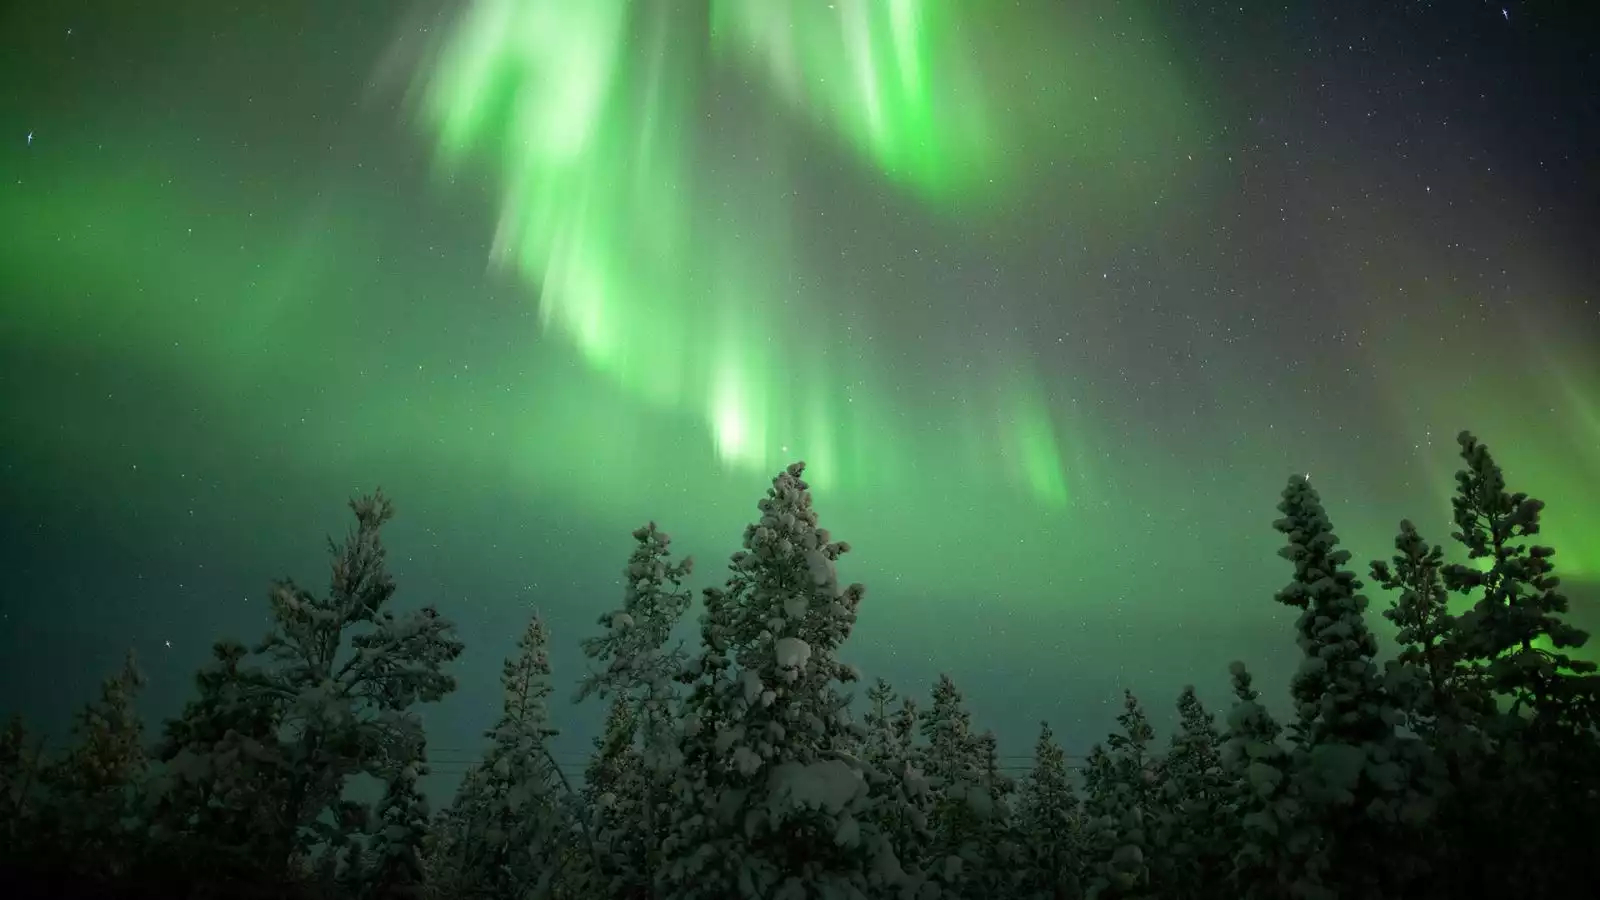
top-left (0, 0), bottom-right (1600, 777)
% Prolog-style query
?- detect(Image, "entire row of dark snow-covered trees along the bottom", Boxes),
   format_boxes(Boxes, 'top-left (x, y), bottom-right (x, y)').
top-left (0, 434), bottom-right (1600, 900)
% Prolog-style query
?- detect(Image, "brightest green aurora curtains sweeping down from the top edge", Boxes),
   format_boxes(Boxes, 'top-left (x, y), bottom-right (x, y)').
top-left (406, 0), bottom-right (1179, 506)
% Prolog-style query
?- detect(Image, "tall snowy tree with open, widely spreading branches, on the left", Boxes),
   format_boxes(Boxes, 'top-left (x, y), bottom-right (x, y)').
top-left (248, 492), bottom-right (462, 879)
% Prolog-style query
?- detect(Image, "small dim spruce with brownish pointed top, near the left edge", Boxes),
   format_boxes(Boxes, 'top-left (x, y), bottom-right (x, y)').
top-left (34, 650), bottom-right (149, 879)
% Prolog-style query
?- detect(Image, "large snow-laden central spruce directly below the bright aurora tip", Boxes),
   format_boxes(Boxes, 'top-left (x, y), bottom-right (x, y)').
top-left (659, 463), bottom-right (904, 900)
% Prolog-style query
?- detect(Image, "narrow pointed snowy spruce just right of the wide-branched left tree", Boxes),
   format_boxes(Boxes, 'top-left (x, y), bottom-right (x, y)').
top-left (450, 615), bottom-right (570, 897)
